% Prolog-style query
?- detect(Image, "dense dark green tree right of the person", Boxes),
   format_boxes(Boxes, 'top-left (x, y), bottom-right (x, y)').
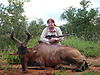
top-left (61, 0), bottom-right (100, 40)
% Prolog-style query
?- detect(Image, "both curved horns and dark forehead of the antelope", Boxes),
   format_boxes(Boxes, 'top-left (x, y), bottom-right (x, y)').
top-left (10, 31), bottom-right (31, 54)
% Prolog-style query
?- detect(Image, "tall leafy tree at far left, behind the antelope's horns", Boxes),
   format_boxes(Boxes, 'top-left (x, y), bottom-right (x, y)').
top-left (0, 0), bottom-right (27, 48)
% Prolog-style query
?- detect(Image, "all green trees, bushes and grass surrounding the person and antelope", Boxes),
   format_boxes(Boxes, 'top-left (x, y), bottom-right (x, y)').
top-left (0, 0), bottom-right (100, 75)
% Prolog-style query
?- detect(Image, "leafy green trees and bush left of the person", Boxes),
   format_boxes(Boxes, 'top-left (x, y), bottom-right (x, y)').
top-left (0, 0), bottom-right (45, 49)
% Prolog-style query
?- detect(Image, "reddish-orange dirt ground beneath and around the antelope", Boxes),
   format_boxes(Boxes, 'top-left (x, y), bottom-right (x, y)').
top-left (0, 57), bottom-right (100, 75)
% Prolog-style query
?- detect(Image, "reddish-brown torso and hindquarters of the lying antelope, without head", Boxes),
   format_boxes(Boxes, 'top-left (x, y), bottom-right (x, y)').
top-left (29, 43), bottom-right (86, 66)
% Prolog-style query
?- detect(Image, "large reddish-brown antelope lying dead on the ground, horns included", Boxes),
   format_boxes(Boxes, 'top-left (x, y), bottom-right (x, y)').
top-left (10, 32), bottom-right (88, 72)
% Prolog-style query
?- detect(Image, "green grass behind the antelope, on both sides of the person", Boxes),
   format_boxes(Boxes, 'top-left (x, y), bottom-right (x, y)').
top-left (0, 37), bottom-right (100, 64)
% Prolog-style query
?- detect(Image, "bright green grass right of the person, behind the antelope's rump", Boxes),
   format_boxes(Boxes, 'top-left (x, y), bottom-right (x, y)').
top-left (61, 37), bottom-right (100, 57)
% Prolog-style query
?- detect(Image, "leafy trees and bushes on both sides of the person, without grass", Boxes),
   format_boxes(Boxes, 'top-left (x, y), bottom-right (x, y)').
top-left (0, 0), bottom-right (100, 49)
